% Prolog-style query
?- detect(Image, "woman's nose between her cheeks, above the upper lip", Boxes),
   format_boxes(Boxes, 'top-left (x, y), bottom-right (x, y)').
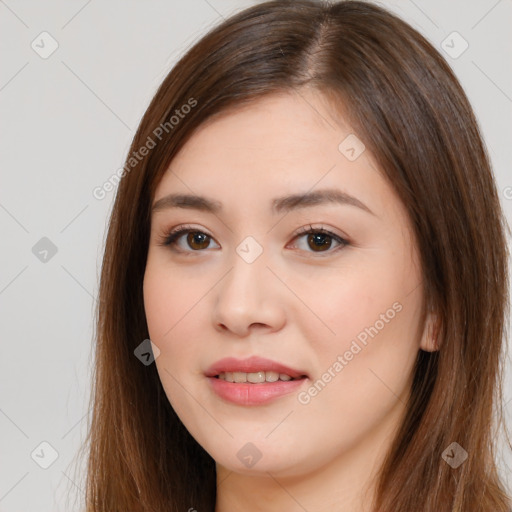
top-left (213, 247), bottom-right (286, 338)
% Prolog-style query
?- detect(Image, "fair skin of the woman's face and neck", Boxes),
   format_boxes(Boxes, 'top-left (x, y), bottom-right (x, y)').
top-left (144, 90), bottom-right (434, 512)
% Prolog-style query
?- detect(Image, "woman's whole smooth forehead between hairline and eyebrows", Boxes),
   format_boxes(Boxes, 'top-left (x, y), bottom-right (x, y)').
top-left (155, 91), bottom-right (393, 222)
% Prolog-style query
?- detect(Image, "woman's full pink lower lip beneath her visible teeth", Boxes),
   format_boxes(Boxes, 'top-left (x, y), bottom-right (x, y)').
top-left (208, 377), bottom-right (307, 405)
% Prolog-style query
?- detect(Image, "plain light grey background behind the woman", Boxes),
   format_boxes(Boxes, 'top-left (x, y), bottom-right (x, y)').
top-left (0, 0), bottom-right (512, 512)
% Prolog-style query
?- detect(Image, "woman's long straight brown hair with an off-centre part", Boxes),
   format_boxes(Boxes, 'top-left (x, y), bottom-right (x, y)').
top-left (77, 0), bottom-right (510, 512)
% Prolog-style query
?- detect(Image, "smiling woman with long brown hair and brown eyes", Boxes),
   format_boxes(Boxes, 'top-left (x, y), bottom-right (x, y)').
top-left (78, 0), bottom-right (510, 512)
